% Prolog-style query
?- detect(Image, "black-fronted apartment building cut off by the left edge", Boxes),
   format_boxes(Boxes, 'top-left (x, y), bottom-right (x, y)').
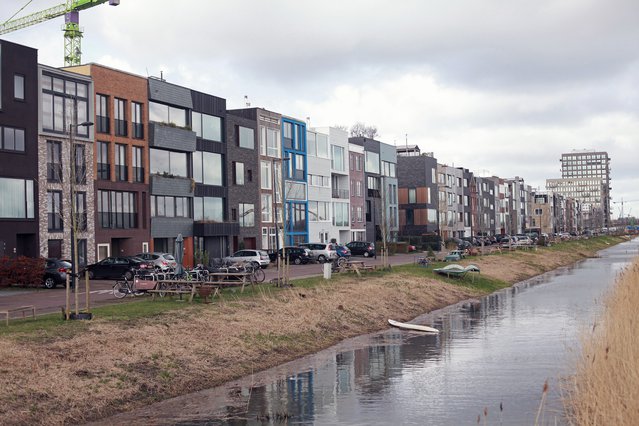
top-left (0, 40), bottom-right (38, 257)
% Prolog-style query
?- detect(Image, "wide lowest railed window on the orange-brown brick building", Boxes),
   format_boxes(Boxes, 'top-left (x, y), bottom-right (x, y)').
top-left (97, 191), bottom-right (137, 229)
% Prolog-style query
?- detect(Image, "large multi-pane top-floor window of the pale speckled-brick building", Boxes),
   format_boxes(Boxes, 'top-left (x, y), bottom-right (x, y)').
top-left (42, 74), bottom-right (89, 137)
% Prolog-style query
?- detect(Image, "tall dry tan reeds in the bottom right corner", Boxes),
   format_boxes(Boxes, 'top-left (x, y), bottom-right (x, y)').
top-left (566, 251), bottom-right (639, 426)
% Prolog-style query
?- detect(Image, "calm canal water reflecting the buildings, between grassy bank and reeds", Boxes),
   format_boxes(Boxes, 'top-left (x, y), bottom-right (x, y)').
top-left (100, 239), bottom-right (639, 425)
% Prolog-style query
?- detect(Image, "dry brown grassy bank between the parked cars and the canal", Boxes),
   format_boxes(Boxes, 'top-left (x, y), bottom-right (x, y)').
top-left (0, 237), bottom-right (622, 424)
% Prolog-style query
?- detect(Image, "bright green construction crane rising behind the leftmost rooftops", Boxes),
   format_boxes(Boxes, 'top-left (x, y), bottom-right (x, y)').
top-left (0, 0), bottom-right (120, 66)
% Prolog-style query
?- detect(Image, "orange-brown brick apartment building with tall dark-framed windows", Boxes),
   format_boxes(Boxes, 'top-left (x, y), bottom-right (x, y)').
top-left (67, 64), bottom-right (151, 260)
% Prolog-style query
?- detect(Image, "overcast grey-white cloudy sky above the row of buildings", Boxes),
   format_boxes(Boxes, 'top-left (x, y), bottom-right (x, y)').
top-left (0, 0), bottom-right (639, 218)
